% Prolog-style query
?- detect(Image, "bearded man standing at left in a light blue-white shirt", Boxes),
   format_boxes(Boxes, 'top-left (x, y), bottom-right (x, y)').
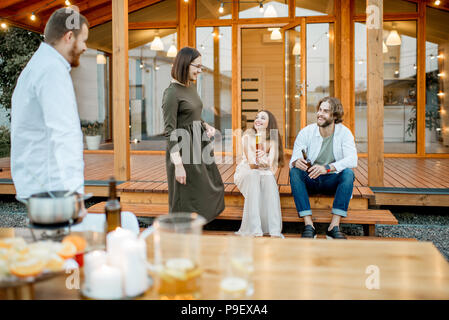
top-left (11, 8), bottom-right (89, 198)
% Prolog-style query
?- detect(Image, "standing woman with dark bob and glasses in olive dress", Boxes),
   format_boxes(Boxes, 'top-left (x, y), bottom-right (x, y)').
top-left (162, 47), bottom-right (224, 222)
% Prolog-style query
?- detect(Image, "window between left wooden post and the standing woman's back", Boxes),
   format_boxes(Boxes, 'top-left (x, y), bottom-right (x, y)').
top-left (129, 29), bottom-right (177, 150)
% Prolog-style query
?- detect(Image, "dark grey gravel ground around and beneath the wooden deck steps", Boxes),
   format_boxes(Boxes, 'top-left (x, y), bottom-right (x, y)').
top-left (0, 196), bottom-right (449, 261)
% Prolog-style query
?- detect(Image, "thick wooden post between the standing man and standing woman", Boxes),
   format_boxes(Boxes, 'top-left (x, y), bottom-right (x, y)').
top-left (112, 0), bottom-right (130, 180)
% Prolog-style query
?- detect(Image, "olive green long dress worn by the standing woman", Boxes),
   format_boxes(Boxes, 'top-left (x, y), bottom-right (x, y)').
top-left (162, 82), bottom-right (225, 222)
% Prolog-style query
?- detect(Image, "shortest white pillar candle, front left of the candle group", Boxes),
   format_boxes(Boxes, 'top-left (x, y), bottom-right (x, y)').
top-left (89, 264), bottom-right (123, 299)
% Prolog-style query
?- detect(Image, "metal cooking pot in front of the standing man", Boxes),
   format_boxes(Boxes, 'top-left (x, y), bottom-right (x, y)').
top-left (16, 190), bottom-right (92, 224)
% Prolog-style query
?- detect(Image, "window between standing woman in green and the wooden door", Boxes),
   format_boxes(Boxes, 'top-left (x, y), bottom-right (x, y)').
top-left (196, 27), bottom-right (232, 152)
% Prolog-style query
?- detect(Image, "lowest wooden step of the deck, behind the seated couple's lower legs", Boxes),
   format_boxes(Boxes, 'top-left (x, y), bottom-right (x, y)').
top-left (88, 202), bottom-right (398, 236)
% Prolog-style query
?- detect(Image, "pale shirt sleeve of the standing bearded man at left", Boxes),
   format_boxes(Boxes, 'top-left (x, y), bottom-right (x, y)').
top-left (36, 68), bottom-right (84, 193)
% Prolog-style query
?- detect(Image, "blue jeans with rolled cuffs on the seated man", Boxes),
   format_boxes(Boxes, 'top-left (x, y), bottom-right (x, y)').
top-left (290, 168), bottom-right (355, 217)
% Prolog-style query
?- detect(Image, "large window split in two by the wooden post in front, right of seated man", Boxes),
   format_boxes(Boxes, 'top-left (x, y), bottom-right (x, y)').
top-left (354, 21), bottom-right (417, 153)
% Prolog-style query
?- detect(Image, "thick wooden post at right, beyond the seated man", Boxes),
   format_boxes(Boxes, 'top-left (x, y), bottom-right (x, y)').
top-left (366, 0), bottom-right (384, 187)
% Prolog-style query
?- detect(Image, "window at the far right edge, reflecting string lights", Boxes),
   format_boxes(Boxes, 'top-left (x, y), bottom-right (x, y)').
top-left (425, 8), bottom-right (449, 153)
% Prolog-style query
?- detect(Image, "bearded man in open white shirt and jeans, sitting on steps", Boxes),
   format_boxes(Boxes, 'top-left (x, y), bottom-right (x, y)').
top-left (290, 97), bottom-right (357, 239)
